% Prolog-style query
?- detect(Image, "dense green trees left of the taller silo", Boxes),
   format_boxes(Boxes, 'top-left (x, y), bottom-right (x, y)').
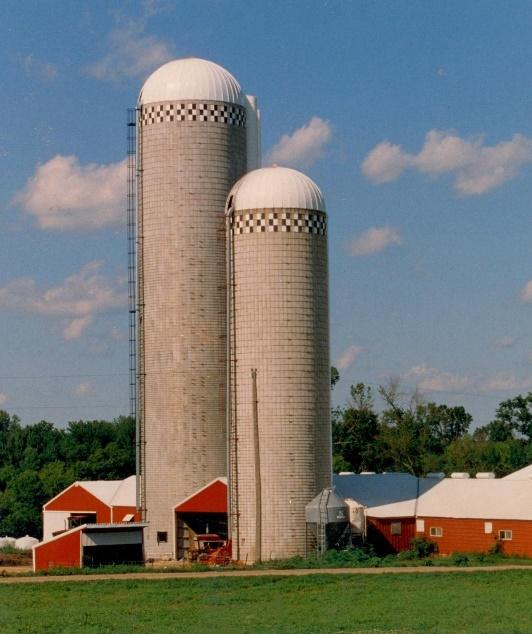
top-left (0, 411), bottom-right (135, 537)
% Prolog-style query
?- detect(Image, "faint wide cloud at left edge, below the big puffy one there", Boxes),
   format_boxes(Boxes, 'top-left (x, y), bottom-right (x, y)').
top-left (0, 261), bottom-right (128, 340)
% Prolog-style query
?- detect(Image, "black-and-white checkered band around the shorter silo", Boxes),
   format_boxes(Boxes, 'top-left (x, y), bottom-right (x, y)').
top-left (233, 209), bottom-right (327, 236)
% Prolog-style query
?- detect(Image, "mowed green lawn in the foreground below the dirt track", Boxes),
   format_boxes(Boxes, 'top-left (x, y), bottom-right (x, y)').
top-left (0, 570), bottom-right (532, 634)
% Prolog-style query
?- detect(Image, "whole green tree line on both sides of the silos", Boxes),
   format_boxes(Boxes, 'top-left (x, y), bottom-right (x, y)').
top-left (0, 368), bottom-right (532, 537)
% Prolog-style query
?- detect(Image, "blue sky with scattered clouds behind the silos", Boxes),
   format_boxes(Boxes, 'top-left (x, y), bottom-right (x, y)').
top-left (0, 0), bottom-right (532, 425)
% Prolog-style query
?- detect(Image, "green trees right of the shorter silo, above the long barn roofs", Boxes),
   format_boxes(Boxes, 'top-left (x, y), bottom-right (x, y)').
top-left (331, 369), bottom-right (532, 477)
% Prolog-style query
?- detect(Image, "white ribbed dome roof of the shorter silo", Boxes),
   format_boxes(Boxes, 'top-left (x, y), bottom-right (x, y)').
top-left (229, 166), bottom-right (325, 211)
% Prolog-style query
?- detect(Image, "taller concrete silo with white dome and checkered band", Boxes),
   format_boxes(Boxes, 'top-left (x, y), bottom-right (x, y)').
top-left (137, 58), bottom-right (259, 558)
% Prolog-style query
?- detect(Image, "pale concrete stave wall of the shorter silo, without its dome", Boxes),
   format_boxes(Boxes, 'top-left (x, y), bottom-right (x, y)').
top-left (232, 210), bottom-right (331, 562)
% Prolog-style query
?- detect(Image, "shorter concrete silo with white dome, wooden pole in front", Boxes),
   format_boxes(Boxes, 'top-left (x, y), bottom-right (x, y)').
top-left (226, 167), bottom-right (331, 562)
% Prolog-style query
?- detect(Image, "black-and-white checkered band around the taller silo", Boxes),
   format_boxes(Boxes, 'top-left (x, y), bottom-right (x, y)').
top-left (141, 102), bottom-right (246, 128)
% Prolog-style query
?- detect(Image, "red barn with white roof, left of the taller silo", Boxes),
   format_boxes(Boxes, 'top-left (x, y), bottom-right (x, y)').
top-left (43, 476), bottom-right (140, 541)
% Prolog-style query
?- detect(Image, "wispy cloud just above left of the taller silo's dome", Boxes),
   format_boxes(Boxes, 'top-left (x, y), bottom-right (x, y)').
top-left (86, 12), bottom-right (174, 82)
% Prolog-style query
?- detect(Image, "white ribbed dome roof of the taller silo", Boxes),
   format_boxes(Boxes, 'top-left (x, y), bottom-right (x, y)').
top-left (139, 57), bottom-right (245, 105)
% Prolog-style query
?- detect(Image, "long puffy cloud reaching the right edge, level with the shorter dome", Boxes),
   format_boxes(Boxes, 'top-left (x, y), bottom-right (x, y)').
top-left (361, 130), bottom-right (532, 196)
